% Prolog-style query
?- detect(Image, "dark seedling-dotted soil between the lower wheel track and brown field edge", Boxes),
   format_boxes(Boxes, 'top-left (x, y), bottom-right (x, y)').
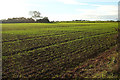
top-left (3, 32), bottom-right (115, 77)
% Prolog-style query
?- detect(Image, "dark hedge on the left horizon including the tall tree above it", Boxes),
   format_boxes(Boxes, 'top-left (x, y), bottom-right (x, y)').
top-left (0, 11), bottom-right (50, 23)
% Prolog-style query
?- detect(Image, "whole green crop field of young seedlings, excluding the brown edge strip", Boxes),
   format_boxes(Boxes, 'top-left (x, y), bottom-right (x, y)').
top-left (2, 22), bottom-right (118, 78)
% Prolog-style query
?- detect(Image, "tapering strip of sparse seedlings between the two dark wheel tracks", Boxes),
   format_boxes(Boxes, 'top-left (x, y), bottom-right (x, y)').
top-left (3, 32), bottom-right (115, 56)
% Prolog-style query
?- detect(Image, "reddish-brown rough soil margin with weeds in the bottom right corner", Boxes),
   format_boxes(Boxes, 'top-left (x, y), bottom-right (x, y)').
top-left (62, 46), bottom-right (118, 78)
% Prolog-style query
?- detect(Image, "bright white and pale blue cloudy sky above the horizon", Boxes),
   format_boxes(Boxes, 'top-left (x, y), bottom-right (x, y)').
top-left (0, 0), bottom-right (119, 21)
